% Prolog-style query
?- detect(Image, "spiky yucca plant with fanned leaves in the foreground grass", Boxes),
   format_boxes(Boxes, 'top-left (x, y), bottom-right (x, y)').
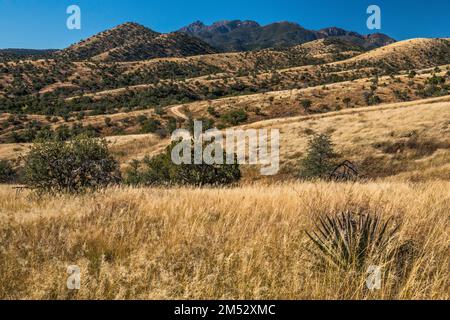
top-left (307, 212), bottom-right (399, 270)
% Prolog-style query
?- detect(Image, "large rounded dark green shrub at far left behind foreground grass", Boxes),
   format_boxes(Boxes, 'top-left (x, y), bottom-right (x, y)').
top-left (24, 136), bottom-right (120, 193)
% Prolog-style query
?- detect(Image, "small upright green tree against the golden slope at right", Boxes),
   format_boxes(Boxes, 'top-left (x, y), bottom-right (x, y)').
top-left (301, 133), bottom-right (337, 178)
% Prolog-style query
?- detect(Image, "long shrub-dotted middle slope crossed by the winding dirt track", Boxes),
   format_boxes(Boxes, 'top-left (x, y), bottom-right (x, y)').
top-left (0, 56), bottom-right (450, 142)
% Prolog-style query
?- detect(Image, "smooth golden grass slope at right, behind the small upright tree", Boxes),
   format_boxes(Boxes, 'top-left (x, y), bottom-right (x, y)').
top-left (243, 96), bottom-right (450, 181)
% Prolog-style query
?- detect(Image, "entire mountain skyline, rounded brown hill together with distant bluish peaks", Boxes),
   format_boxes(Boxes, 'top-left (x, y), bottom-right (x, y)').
top-left (0, 20), bottom-right (395, 62)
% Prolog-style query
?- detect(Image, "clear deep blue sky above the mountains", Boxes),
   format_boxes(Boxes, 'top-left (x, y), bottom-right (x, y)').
top-left (0, 0), bottom-right (450, 49)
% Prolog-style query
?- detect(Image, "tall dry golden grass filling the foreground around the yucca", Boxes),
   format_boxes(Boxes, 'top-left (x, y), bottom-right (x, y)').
top-left (0, 181), bottom-right (450, 299)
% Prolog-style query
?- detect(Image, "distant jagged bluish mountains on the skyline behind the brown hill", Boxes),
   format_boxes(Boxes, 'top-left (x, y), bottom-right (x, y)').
top-left (179, 20), bottom-right (395, 51)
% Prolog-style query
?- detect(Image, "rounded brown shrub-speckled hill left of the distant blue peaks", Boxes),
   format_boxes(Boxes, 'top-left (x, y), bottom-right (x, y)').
top-left (57, 23), bottom-right (215, 62)
